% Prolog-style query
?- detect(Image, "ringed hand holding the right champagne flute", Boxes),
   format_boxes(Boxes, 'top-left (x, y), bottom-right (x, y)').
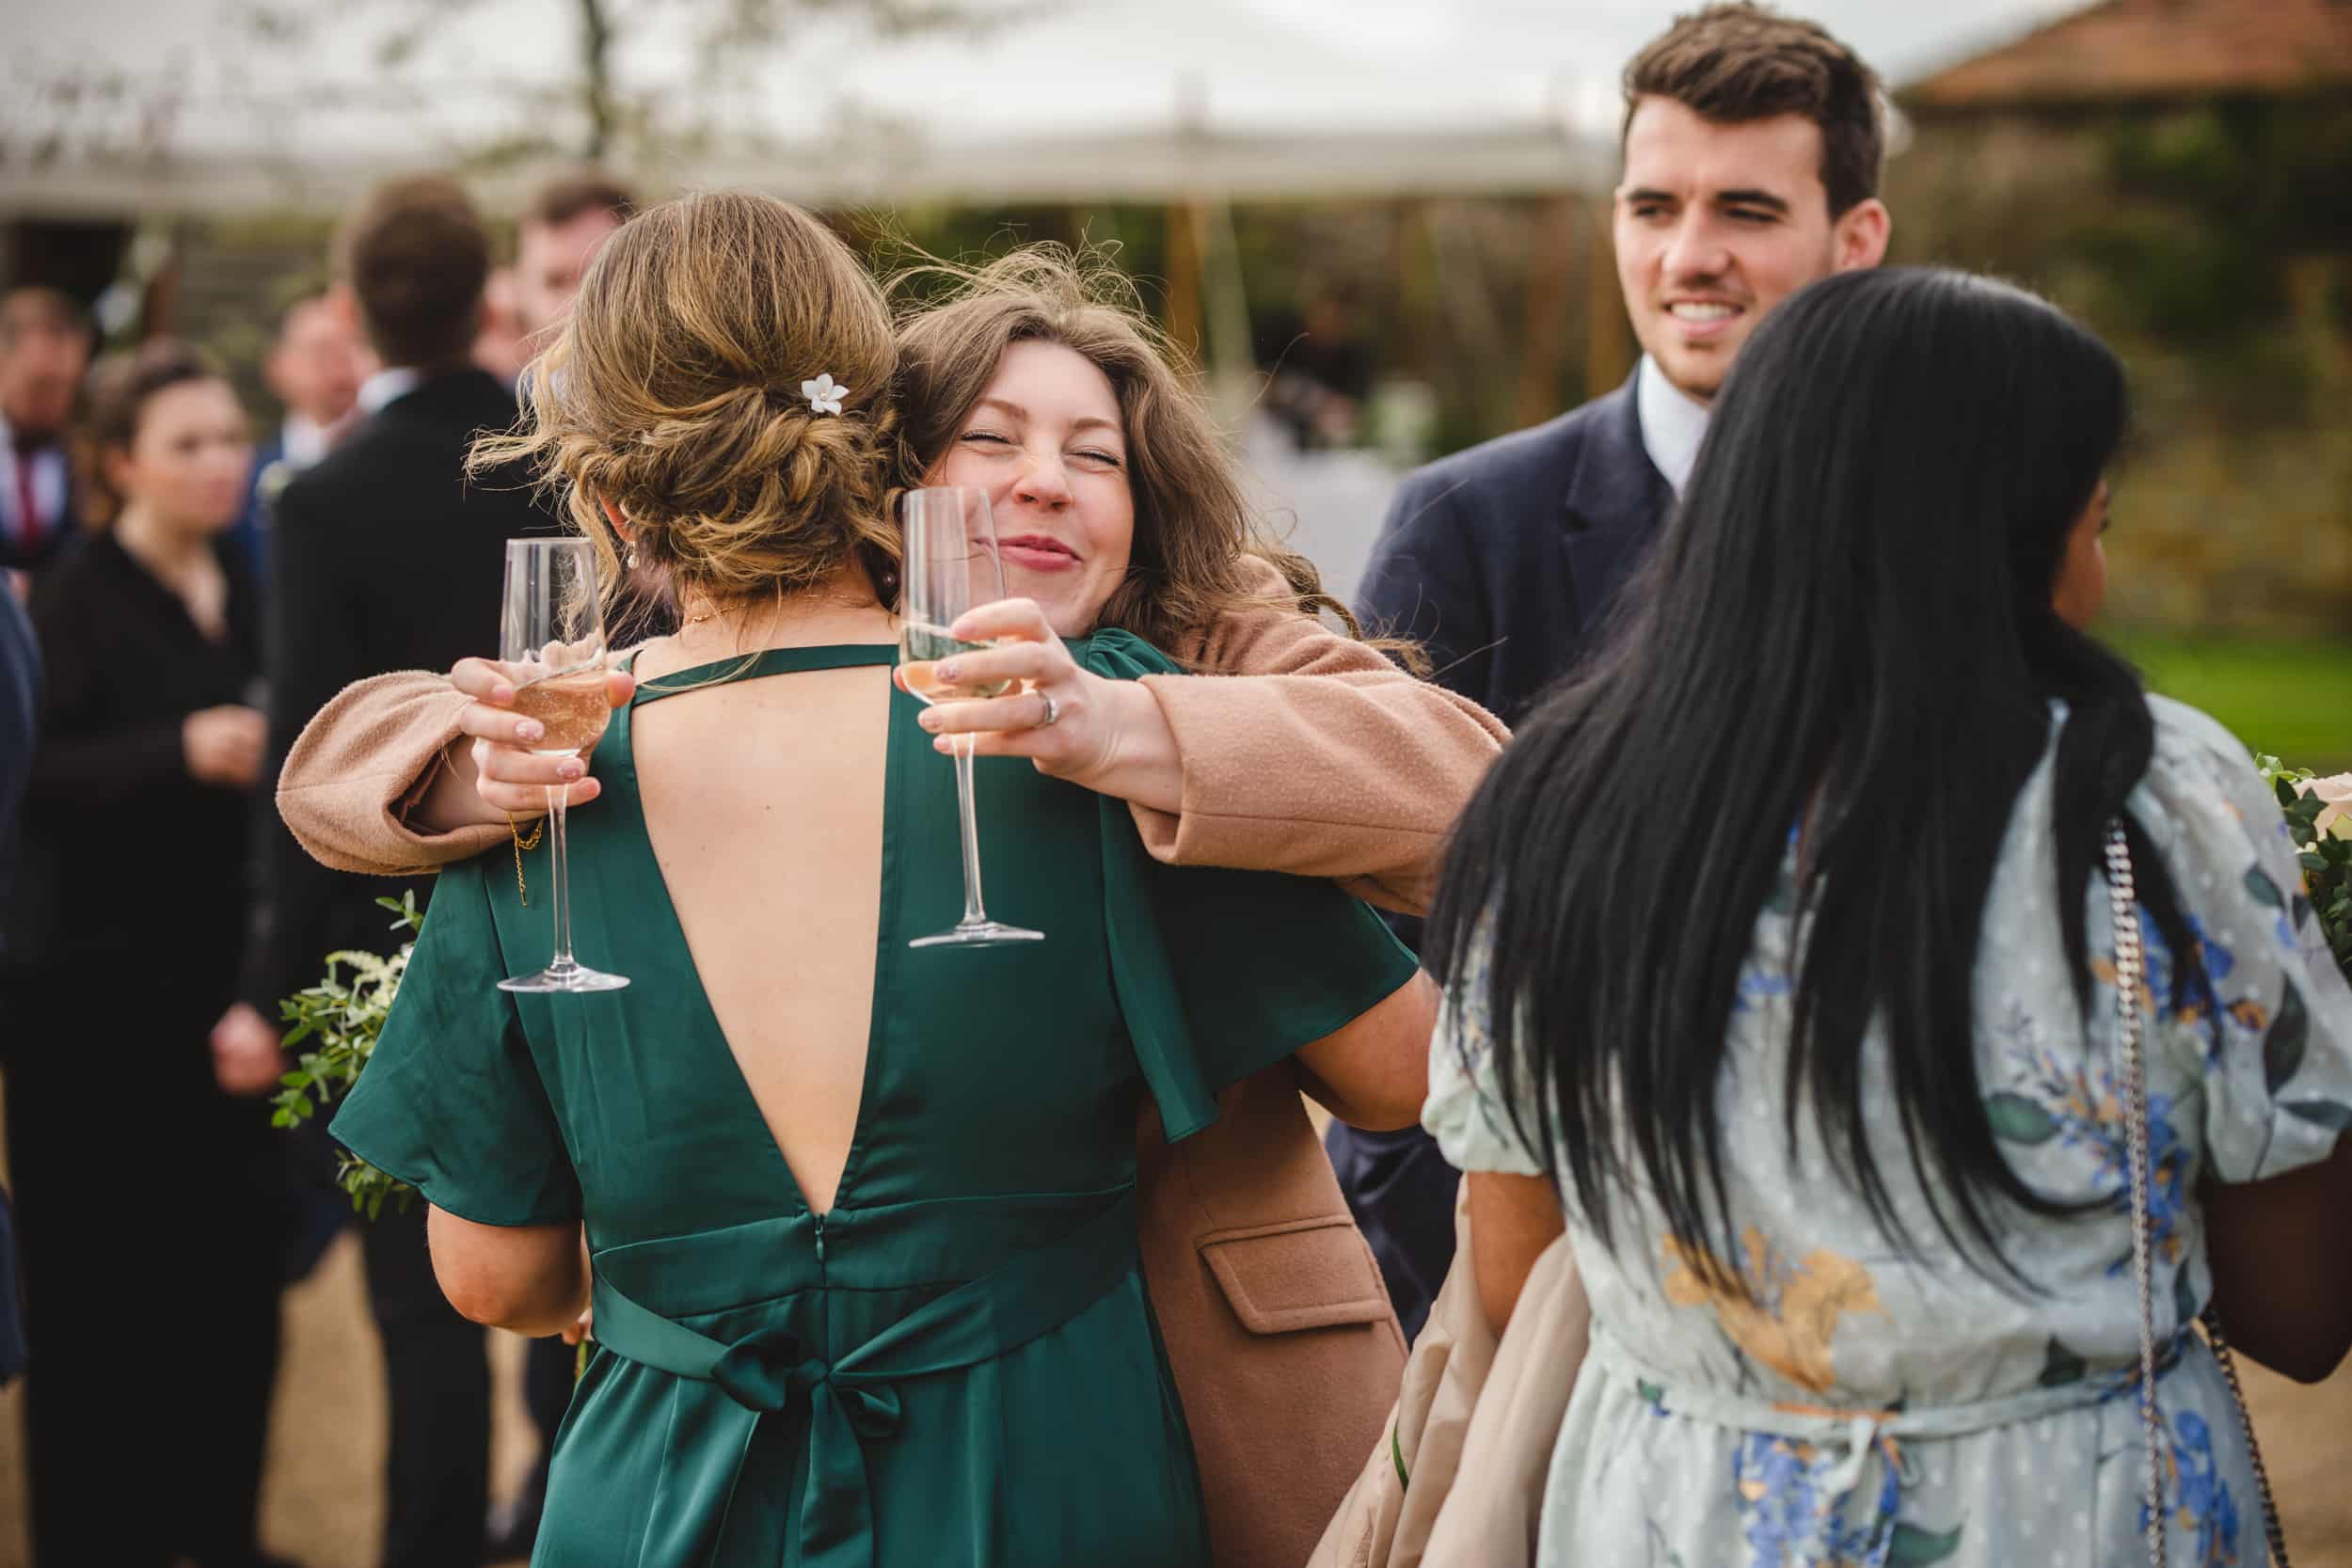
top-left (897, 599), bottom-right (1184, 811)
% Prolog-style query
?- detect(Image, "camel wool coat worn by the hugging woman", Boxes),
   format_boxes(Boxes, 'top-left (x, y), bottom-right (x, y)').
top-left (278, 566), bottom-right (1505, 1568)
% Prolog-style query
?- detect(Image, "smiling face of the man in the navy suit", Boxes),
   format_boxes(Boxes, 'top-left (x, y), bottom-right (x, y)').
top-left (1616, 96), bottom-right (1886, 402)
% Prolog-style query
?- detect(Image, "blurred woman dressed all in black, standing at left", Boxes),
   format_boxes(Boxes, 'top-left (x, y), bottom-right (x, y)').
top-left (0, 341), bottom-right (282, 1568)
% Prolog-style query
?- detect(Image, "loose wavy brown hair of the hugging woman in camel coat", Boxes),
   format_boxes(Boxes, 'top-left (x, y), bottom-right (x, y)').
top-left (892, 245), bottom-right (1358, 658)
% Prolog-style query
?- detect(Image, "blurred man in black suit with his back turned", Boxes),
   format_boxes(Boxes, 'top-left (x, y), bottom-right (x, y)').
top-left (245, 176), bottom-right (550, 1568)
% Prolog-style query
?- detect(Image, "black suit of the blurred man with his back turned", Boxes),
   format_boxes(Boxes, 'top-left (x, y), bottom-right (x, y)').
top-left (247, 369), bottom-right (550, 1568)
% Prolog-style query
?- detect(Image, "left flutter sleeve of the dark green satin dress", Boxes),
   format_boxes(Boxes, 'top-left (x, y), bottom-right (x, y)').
top-left (329, 861), bottom-right (581, 1225)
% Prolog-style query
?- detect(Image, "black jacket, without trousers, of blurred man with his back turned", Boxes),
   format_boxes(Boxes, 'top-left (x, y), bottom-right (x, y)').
top-left (245, 369), bottom-right (553, 1018)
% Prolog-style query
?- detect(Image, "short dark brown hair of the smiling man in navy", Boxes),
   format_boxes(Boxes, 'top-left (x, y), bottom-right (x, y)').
top-left (1618, 2), bottom-right (1886, 218)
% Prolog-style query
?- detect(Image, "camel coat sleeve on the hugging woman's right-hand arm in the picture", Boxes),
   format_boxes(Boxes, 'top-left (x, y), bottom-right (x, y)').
top-left (1152, 562), bottom-right (1510, 914)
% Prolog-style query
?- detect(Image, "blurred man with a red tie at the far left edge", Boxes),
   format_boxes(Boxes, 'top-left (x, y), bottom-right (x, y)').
top-left (0, 289), bottom-right (89, 571)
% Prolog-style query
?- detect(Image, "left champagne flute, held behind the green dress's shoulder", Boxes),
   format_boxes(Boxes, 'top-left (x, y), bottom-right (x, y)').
top-left (499, 538), bottom-right (628, 992)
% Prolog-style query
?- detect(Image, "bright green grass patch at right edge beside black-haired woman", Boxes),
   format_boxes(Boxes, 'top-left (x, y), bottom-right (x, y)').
top-left (2107, 630), bottom-right (2352, 773)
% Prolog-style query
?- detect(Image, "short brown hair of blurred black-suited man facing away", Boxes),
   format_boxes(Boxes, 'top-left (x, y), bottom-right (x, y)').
top-left (337, 174), bottom-right (489, 369)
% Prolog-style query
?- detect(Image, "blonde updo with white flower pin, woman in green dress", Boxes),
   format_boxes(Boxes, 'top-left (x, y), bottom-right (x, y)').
top-left (473, 190), bottom-right (898, 609)
